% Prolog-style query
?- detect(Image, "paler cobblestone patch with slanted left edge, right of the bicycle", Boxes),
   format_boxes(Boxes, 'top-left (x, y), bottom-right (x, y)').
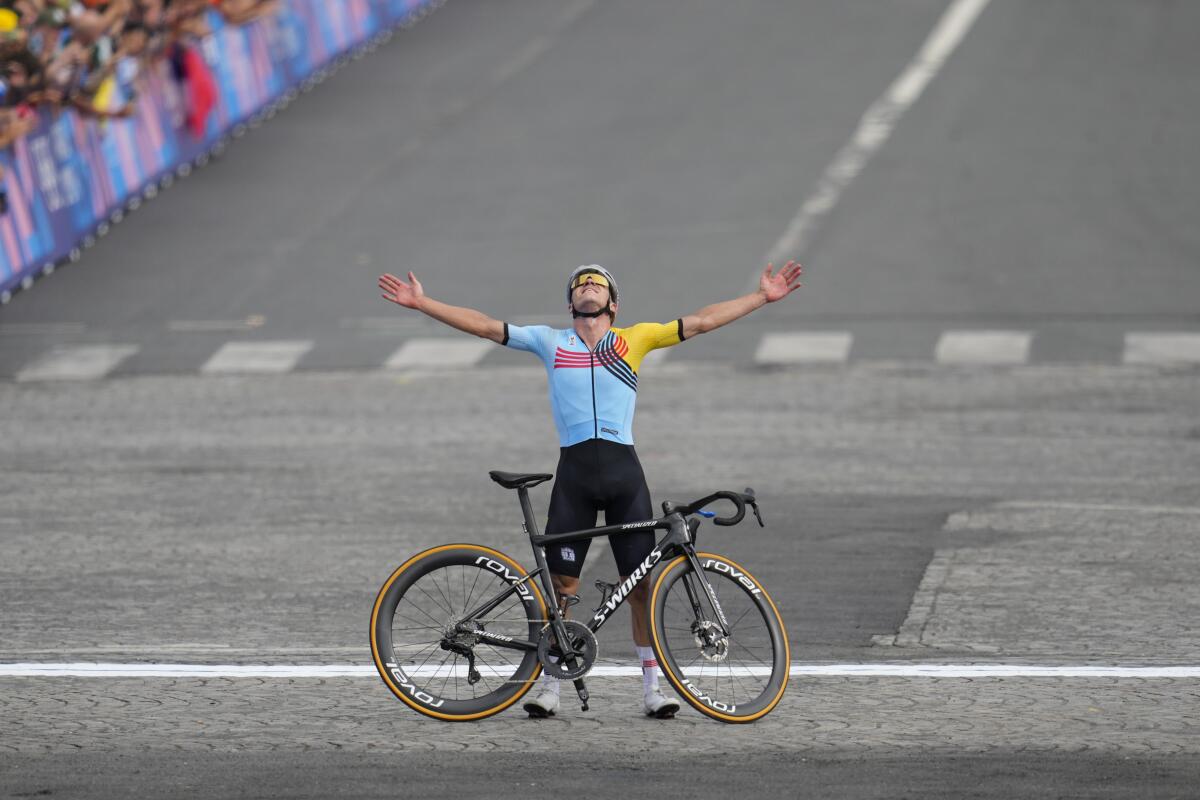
top-left (878, 503), bottom-right (1200, 663)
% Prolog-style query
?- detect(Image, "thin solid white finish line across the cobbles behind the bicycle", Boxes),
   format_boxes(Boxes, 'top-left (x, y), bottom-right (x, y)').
top-left (0, 663), bottom-right (1200, 678)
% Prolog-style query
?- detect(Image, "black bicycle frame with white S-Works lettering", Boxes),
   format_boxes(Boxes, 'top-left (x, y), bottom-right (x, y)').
top-left (457, 487), bottom-right (730, 651)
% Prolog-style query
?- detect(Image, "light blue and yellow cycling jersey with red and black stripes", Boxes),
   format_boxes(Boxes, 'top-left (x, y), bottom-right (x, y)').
top-left (502, 319), bottom-right (683, 447)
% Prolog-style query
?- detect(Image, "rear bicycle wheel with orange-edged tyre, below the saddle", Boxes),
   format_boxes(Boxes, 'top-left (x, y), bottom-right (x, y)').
top-left (371, 545), bottom-right (546, 721)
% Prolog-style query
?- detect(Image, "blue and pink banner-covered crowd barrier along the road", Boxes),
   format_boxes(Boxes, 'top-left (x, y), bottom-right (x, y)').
top-left (0, 0), bottom-right (438, 302)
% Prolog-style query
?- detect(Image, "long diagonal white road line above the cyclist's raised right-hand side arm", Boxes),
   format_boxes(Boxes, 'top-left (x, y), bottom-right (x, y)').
top-left (752, 0), bottom-right (989, 278)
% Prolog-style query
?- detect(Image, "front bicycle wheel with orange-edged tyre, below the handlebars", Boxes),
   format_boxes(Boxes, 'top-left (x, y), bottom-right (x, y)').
top-left (650, 553), bottom-right (791, 722)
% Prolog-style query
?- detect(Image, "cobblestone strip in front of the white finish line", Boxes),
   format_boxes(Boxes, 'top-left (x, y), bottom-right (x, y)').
top-left (0, 678), bottom-right (1200, 756)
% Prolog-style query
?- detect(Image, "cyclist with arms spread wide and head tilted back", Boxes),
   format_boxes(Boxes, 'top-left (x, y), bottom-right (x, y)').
top-left (379, 261), bottom-right (802, 718)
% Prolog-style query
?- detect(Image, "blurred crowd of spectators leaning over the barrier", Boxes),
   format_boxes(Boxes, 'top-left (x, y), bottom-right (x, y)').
top-left (0, 0), bottom-right (278, 212)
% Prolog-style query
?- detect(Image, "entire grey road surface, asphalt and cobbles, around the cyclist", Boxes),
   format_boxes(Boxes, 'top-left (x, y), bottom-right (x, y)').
top-left (0, 0), bottom-right (1200, 798)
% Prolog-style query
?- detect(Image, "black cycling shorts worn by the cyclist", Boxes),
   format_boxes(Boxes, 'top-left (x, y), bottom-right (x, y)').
top-left (546, 439), bottom-right (654, 578)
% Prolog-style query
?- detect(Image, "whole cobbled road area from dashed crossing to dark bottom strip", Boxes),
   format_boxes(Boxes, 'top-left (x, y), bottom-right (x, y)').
top-left (0, 365), bottom-right (1200, 796)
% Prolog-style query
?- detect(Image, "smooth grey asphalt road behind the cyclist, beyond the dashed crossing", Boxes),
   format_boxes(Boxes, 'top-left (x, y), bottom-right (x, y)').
top-left (0, 0), bottom-right (1200, 374)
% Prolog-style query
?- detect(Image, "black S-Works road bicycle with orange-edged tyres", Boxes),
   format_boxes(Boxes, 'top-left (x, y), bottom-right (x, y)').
top-left (371, 471), bottom-right (791, 722)
